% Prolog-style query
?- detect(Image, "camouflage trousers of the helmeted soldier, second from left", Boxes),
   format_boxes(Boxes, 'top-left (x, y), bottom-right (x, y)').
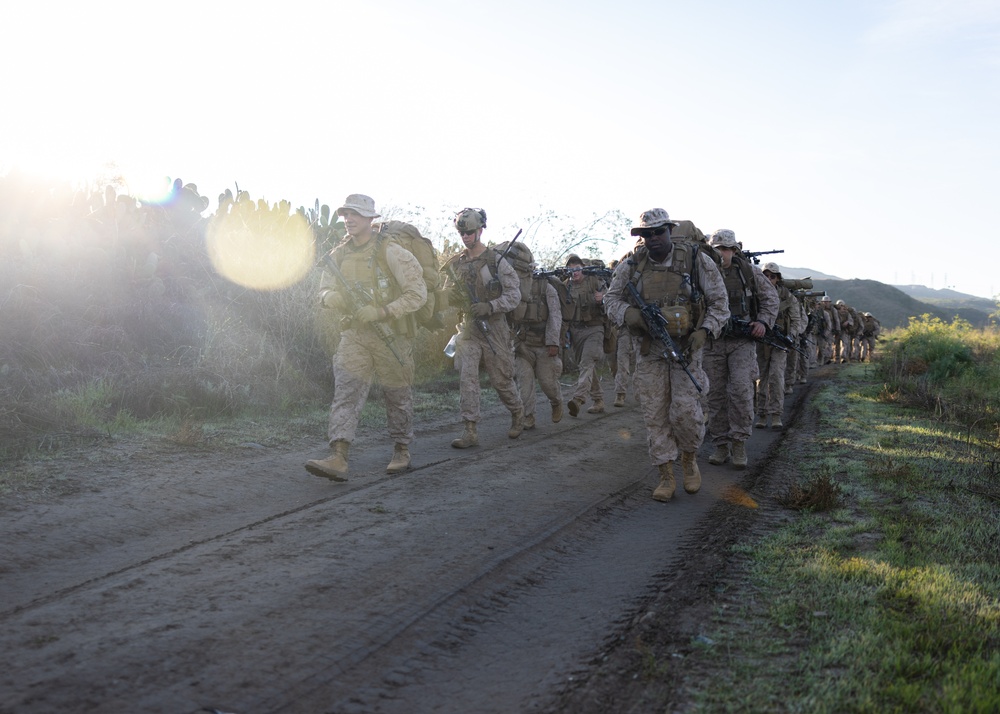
top-left (455, 315), bottom-right (524, 422)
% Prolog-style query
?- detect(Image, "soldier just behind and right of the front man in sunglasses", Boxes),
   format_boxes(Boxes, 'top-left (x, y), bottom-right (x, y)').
top-left (705, 229), bottom-right (778, 469)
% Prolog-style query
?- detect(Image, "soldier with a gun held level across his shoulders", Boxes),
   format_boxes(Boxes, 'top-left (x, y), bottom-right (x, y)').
top-left (563, 254), bottom-right (606, 417)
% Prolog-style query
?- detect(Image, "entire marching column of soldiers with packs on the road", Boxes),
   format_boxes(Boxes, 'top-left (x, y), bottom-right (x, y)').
top-left (305, 194), bottom-right (881, 501)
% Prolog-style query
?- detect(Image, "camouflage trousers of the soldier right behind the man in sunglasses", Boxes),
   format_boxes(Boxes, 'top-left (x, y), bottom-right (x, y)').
top-left (705, 337), bottom-right (758, 444)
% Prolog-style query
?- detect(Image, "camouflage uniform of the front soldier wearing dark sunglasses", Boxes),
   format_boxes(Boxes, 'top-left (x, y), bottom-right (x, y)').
top-left (604, 217), bottom-right (729, 472)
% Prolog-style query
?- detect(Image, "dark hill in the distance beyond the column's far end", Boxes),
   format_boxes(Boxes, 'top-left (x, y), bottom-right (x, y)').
top-left (813, 279), bottom-right (990, 328)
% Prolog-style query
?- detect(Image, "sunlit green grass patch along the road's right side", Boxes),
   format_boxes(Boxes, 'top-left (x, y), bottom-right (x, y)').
top-left (689, 358), bottom-right (1000, 712)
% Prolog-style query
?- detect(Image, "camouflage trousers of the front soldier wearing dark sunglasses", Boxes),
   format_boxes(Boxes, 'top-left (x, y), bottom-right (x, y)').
top-left (633, 350), bottom-right (709, 466)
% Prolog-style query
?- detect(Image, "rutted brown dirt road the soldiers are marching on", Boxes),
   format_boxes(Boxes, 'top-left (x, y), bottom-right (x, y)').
top-left (0, 376), bottom-right (807, 714)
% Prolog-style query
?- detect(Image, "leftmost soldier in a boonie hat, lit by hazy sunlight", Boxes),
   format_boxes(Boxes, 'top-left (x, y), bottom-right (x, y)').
top-left (305, 193), bottom-right (427, 481)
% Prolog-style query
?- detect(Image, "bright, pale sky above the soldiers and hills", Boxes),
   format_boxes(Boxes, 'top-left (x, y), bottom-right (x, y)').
top-left (0, 0), bottom-right (1000, 297)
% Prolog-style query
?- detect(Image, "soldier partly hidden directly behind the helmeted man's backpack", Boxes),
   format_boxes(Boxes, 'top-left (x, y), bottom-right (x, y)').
top-left (504, 243), bottom-right (562, 429)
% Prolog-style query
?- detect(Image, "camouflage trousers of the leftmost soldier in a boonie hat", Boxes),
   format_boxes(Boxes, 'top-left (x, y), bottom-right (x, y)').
top-left (327, 327), bottom-right (413, 444)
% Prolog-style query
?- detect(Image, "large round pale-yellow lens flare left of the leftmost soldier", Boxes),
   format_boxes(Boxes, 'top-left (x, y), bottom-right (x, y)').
top-left (205, 206), bottom-right (316, 290)
